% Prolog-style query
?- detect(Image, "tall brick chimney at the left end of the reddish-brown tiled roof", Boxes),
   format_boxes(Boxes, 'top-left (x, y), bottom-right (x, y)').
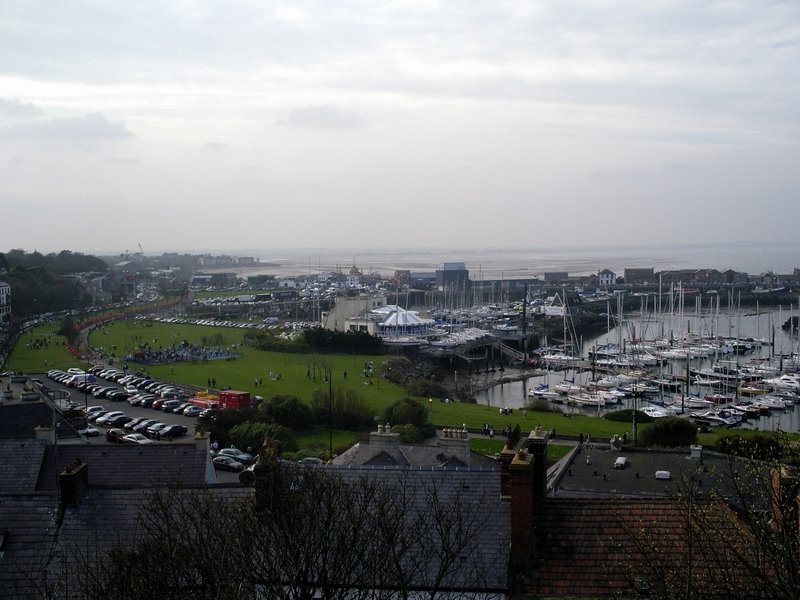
top-left (510, 427), bottom-right (547, 570)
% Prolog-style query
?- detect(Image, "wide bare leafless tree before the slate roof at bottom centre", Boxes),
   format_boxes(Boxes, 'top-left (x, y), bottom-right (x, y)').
top-left (54, 458), bottom-right (504, 600)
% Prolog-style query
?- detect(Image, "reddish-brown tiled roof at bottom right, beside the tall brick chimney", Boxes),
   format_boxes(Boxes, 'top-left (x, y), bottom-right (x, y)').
top-left (517, 498), bottom-right (754, 598)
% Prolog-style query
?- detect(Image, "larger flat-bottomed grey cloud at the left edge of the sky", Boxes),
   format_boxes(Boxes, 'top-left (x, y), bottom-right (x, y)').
top-left (0, 113), bottom-right (134, 142)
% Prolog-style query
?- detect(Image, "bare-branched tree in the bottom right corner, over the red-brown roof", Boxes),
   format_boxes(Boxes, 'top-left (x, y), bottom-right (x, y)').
top-left (620, 432), bottom-right (800, 600)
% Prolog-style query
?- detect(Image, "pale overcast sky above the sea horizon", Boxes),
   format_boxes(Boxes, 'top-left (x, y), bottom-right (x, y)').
top-left (0, 0), bottom-right (800, 253)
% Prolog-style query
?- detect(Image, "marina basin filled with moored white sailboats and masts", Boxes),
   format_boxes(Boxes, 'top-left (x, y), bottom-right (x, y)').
top-left (475, 311), bottom-right (800, 431)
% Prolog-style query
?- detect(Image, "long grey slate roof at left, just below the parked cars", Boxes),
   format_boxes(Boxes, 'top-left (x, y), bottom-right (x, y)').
top-left (38, 444), bottom-right (209, 490)
